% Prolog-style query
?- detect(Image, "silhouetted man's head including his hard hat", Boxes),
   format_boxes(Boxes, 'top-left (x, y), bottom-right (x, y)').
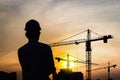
top-left (25, 19), bottom-right (41, 40)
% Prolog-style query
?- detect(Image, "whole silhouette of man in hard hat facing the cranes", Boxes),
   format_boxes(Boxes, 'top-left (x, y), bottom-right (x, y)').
top-left (18, 19), bottom-right (55, 80)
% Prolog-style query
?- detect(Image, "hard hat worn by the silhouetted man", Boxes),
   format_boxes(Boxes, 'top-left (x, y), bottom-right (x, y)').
top-left (25, 19), bottom-right (41, 32)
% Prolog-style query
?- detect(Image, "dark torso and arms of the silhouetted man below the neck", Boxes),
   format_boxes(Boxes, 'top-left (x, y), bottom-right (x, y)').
top-left (18, 40), bottom-right (55, 80)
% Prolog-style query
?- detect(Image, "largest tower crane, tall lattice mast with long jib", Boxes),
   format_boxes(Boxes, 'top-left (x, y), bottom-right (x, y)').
top-left (50, 29), bottom-right (113, 80)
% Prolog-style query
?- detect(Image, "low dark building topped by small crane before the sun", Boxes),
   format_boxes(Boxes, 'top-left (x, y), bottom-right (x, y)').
top-left (53, 54), bottom-right (84, 80)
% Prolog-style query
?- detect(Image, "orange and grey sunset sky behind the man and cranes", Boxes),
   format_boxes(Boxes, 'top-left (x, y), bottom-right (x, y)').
top-left (0, 0), bottom-right (120, 80)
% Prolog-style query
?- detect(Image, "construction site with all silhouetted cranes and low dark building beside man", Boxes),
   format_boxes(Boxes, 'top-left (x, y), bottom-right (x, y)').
top-left (50, 29), bottom-right (117, 80)
